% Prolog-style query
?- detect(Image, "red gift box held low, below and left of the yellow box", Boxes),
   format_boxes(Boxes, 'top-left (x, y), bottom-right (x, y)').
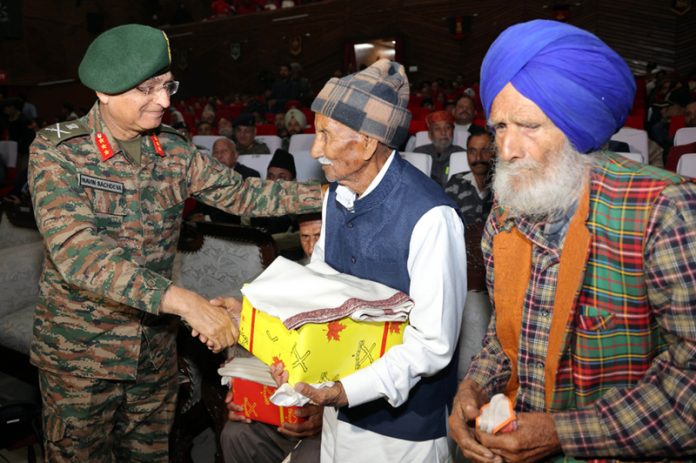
top-left (230, 377), bottom-right (306, 426)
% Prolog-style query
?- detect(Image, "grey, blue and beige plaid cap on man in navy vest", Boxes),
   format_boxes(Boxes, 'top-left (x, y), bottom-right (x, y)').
top-left (312, 59), bottom-right (411, 148)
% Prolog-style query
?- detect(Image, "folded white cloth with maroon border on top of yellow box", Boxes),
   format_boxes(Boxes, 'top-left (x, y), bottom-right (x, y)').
top-left (242, 257), bottom-right (413, 329)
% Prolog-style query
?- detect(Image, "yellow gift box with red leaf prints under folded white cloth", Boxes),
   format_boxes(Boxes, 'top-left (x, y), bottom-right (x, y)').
top-left (238, 297), bottom-right (407, 384)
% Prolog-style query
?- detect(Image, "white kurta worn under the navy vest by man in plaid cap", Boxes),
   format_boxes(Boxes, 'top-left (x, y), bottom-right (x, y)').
top-left (312, 152), bottom-right (466, 463)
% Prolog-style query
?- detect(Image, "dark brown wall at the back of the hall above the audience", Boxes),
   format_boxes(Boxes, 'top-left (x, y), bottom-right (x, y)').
top-left (0, 0), bottom-right (696, 122)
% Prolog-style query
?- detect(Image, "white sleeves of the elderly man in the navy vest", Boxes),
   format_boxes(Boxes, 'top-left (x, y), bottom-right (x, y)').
top-left (338, 206), bottom-right (466, 407)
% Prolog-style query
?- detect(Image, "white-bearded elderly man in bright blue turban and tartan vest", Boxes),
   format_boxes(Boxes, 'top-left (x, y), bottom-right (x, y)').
top-left (450, 20), bottom-right (696, 462)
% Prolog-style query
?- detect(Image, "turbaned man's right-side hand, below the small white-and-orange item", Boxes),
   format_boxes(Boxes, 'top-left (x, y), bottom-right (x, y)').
top-left (476, 413), bottom-right (561, 463)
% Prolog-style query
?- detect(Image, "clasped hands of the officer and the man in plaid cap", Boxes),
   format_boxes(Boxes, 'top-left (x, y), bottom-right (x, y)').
top-left (160, 285), bottom-right (242, 353)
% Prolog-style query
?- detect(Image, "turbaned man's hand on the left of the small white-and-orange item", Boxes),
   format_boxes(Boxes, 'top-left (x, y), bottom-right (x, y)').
top-left (449, 379), bottom-right (503, 463)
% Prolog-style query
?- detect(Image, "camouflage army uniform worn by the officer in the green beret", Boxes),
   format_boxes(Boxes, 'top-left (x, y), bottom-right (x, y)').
top-left (29, 104), bottom-right (321, 461)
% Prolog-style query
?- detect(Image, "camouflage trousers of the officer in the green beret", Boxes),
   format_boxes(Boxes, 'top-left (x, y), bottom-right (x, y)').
top-left (39, 342), bottom-right (178, 463)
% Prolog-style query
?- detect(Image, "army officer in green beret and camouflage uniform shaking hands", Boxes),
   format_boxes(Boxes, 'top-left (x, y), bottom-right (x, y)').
top-left (29, 24), bottom-right (321, 462)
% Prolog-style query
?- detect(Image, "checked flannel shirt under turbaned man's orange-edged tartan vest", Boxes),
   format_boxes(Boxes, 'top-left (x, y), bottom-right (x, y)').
top-left (467, 155), bottom-right (696, 461)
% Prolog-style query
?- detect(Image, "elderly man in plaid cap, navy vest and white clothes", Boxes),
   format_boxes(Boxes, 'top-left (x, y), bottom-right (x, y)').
top-left (284, 60), bottom-right (466, 462)
